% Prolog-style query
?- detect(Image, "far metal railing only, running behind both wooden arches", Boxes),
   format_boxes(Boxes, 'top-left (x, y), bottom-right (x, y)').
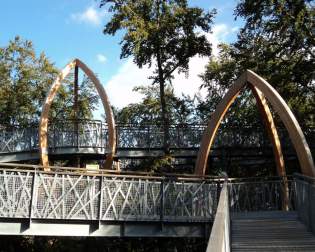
top-left (0, 120), bottom-right (315, 153)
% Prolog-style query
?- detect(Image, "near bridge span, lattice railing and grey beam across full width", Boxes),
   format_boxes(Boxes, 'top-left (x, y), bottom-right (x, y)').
top-left (0, 164), bottom-right (315, 243)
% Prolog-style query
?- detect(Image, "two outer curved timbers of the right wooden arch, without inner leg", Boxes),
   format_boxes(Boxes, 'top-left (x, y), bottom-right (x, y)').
top-left (195, 70), bottom-right (315, 177)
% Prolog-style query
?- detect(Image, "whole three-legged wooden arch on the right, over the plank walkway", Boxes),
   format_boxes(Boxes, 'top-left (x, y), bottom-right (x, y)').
top-left (195, 70), bottom-right (315, 177)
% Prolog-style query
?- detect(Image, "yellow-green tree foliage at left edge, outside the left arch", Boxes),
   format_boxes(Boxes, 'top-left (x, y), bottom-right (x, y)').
top-left (0, 37), bottom-right (57, 125)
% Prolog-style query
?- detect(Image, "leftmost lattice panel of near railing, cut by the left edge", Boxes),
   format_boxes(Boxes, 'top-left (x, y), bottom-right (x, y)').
top-left (0, 170), bottom-right (33, 218)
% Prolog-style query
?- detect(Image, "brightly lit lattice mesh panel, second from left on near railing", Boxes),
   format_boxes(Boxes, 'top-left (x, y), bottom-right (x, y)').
top-left (33, 174), bottom-right (100, 219)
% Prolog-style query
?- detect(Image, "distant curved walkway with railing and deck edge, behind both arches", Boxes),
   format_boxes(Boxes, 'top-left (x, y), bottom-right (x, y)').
top-left (0, 120), bottom-right (315, 162)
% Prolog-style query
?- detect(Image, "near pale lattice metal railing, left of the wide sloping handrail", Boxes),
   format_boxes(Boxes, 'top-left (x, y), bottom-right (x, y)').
top-left (0, 165), bottom-right (219, 222)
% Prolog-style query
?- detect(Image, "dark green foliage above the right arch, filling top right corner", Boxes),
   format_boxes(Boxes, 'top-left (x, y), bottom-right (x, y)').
top-left (202, 0), bottom-right (315, 128)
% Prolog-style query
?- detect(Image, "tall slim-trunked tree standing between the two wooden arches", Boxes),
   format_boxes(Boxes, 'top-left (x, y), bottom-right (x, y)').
top-left (100, 0), bottom-right (215, 153)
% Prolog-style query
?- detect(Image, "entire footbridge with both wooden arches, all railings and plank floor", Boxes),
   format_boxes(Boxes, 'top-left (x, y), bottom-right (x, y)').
top-left (0, 59), bottom-right (315, 248)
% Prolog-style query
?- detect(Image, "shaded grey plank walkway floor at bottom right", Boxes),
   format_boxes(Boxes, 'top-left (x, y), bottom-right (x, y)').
top-left (231, 211), bottom-right (315, 252)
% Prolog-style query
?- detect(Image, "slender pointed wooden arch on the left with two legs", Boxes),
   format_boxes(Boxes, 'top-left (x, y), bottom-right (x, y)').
top-left (39, 59), bottom-right (116, 170)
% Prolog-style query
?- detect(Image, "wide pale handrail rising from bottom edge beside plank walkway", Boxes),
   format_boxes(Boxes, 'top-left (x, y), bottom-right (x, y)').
top-left (206, 181), bottom-right (231, 252)
